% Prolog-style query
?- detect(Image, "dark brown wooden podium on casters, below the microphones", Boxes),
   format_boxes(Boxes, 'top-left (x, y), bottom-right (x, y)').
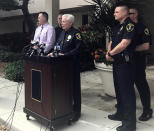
top-left (24, 56), bottom-right (73, 130)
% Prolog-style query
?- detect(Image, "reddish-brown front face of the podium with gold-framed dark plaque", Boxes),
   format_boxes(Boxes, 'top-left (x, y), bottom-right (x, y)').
top-left (24, 61), bottom-right (53, 119)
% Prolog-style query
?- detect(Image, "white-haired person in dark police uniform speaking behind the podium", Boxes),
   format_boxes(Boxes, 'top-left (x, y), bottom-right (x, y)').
top-left (48, 14), bottom-right (82, 121)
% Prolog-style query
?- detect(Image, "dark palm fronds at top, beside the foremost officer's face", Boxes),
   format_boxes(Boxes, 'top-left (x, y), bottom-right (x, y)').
top-left (90, 0), bottom-right (116, 41)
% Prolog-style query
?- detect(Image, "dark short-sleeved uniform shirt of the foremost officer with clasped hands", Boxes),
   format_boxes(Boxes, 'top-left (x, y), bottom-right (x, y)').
top-left (111, 18), bottom-right (136, 52)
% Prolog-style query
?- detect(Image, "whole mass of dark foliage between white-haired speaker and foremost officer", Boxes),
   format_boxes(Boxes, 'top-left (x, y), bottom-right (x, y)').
top-left (79, 0), bottom-right (115, 71)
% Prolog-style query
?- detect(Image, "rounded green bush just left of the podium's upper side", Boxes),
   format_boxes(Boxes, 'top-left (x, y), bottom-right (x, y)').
top-left (4, 60), bottom-right (24, 82)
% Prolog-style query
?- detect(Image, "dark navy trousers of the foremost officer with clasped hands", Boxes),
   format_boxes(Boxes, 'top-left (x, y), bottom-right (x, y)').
top-left (113, 61), bottom-right (136, 128)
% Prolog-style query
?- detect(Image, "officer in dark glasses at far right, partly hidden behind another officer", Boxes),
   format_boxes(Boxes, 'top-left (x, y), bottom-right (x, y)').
top-left (129, 8), bottom-right (153, 121)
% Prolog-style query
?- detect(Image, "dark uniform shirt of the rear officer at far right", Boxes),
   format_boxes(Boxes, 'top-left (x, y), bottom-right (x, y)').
top-left (136, 22), bottom-right (152, 45)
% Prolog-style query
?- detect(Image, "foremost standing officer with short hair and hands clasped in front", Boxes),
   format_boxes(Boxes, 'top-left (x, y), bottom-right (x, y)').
top-left (106, 5), bottom-right (136, 131)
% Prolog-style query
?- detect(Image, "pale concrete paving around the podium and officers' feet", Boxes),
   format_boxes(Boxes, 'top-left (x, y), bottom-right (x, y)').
top-left (0, 67), bottom-right (154, 131)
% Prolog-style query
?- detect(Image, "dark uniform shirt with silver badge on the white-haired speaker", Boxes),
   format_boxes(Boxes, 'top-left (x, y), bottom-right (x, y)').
top-left (57, 27), bottom-right (82, 55)
